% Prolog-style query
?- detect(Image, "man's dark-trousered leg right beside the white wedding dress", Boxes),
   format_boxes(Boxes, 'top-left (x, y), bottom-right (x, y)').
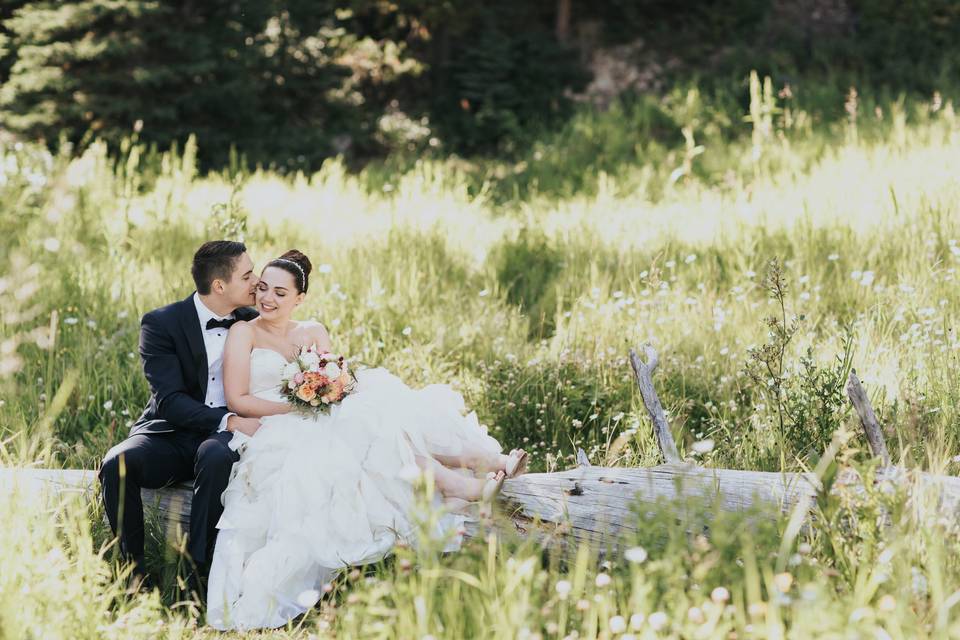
top-left (188, 431), bottom-right (240, 572)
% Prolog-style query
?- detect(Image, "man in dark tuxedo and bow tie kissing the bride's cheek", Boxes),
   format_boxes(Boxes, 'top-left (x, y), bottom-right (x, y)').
top-left (100, 240), bottom-right (260, 597)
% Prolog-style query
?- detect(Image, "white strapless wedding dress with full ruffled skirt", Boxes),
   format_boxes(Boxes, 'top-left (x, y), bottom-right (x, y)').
top-left (207, 348), bottom-right (501, 630)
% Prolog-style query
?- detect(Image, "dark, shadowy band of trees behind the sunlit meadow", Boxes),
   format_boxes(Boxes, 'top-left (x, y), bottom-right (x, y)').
top-left (0, 0), bottom-right (960, 166)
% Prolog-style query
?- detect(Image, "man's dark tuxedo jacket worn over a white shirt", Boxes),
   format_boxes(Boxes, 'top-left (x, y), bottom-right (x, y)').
top-left (130, 293), bottom-right (258, 435)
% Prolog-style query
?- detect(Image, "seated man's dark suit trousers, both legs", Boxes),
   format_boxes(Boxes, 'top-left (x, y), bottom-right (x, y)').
top-left (99, 429), bottom-right (240, 572)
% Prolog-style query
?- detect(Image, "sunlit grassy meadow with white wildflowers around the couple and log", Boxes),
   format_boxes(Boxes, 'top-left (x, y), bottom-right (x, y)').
top-left (0, 81), bottom-right (960, 638)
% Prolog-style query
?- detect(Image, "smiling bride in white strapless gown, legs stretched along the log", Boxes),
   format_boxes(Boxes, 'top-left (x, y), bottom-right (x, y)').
top-left (207, 250), bottom-right (527, 630)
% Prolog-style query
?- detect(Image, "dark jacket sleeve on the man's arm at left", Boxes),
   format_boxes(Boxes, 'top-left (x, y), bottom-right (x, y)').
top-left (140, 313), bottom-right (227, 431)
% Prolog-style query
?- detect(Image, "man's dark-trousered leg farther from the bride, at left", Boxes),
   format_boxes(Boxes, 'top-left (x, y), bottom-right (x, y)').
top-left (99, 433), bottom-right (193, 570)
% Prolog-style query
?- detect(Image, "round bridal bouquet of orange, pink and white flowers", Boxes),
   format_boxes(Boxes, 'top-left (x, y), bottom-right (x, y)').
top-left (281, 345), bottom-right (357, 413)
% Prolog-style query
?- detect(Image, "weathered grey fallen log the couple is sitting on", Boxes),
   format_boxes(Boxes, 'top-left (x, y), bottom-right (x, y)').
top-left (7, 464), bottom-right (960, 550)
